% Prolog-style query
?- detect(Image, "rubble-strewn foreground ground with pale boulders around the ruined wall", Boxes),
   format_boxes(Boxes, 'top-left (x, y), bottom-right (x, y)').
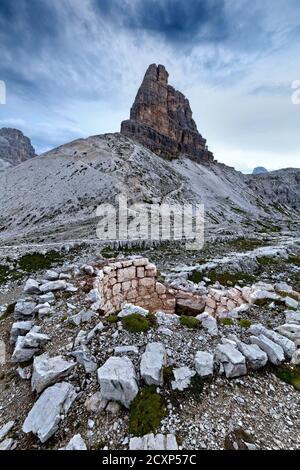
top-left (0, 237), bottom-right (300, 450)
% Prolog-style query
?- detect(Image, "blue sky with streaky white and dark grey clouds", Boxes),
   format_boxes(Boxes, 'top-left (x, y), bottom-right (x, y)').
top-left (0, 0), bottom-right (300, 172)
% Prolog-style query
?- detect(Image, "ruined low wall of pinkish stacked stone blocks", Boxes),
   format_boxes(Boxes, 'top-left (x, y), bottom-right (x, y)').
top-left (95, 258), bottom-right (176, 315)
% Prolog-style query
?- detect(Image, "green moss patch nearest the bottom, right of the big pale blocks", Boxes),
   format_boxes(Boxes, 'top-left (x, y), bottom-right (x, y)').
top-left (129, 386), bottom-right (166, 436)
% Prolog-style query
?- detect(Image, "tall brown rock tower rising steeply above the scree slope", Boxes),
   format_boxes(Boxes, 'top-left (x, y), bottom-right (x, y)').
top-left (121, 64), bottom-right (213, 162)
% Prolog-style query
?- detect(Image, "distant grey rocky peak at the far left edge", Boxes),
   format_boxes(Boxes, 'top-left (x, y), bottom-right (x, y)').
top-left (0, 128), bottom-right (36, 171)
